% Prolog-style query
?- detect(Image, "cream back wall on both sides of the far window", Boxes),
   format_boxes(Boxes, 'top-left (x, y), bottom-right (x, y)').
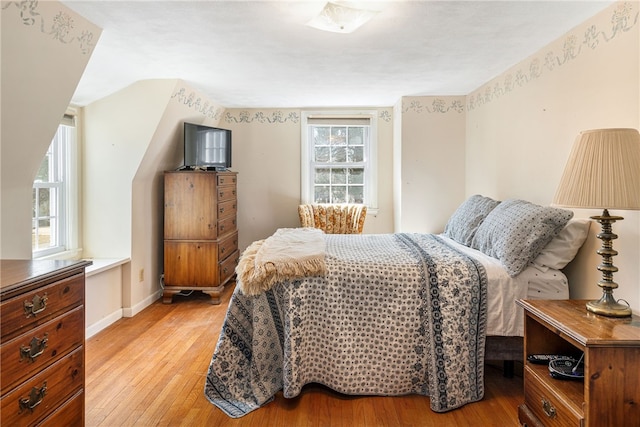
top-left (220, 108), bottom-right (393, 250)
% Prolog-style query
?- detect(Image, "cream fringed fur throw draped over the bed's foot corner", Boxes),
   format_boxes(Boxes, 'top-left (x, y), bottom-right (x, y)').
top-left (236, 228), bottom-right (326, 295)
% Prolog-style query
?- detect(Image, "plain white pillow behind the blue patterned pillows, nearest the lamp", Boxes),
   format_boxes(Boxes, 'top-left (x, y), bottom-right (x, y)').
top-left (533, 218), bottom-right (592, 270)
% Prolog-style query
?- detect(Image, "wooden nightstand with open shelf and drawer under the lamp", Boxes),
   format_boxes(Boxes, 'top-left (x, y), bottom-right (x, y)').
top-left (516, 300), bottom-right (640, 427)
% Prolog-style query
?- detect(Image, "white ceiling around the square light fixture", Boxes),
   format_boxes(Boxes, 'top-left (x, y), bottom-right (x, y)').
top-left (63, 0), bottom-right (612, 108)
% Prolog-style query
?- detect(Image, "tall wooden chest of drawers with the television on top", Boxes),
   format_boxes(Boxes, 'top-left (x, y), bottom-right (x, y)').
top-left (162, 170), bottom-right (239, 304)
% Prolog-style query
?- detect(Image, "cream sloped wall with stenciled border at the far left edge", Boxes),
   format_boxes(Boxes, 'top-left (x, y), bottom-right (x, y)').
top-left (0, 2), bottom-right (102, 259)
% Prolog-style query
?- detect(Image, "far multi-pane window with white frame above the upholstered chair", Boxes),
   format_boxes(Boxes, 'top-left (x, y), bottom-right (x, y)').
top-left (301, 112), bottom-right (377, 208)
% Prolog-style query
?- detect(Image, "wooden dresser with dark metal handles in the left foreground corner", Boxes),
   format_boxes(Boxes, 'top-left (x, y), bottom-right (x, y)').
top-left (0, 260), bottom-right (91, 426)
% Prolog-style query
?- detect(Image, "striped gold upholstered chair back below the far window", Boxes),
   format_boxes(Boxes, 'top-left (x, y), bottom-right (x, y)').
top-left (298, 203), bottom-right (367, 234)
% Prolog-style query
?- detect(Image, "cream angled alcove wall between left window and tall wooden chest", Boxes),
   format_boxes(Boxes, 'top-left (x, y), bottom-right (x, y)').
top-left (83, 79), bottom-right (224, 316)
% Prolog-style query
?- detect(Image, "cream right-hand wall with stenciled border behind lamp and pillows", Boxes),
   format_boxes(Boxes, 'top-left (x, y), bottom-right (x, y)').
top-left (465, 2), bottom-right (640, 311)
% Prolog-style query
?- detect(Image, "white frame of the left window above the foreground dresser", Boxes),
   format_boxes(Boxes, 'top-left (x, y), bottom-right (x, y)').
top-left (32, 108), bottom-right (81, 259)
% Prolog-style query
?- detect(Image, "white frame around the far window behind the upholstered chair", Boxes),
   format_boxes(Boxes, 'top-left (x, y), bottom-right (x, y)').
top-left (300, 110), bottom-right (378, 214)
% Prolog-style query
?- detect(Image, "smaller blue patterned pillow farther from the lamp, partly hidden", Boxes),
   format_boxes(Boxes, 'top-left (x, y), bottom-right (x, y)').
top-left (444, 194), bottom-right (500, 246)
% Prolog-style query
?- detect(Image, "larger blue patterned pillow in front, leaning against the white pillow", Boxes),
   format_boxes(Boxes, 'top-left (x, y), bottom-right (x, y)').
top-left (471, 199), bottom-right (573, 277)
